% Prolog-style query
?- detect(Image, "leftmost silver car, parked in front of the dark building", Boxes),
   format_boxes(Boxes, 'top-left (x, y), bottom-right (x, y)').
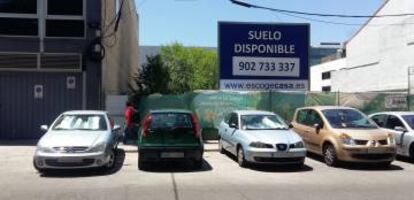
top-left (33, 111), bottom-right (120, 172)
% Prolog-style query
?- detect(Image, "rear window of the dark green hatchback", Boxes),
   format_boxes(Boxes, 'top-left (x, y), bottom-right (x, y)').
top-left (149, 113), bottom-right (193, 130)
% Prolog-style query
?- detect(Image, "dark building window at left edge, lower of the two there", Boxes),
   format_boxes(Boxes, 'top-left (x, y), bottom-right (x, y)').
top-left (0, 18), bottom-right (39, 36)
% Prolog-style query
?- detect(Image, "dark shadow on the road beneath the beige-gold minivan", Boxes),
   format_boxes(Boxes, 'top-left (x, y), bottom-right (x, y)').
top-left (307, 152), bottom-right (404, 171)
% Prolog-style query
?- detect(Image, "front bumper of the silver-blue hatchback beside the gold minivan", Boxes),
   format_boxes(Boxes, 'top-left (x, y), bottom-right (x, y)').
top-left (245, 148), bottom-right (306, 165)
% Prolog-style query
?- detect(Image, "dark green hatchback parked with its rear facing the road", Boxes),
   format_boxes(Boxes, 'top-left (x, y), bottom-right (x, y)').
top-left (138, 110), bottom-right (204, 169)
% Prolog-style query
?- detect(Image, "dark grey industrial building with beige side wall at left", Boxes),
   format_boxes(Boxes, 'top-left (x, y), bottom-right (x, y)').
top-left (0, 0), bottom-right (138, 140)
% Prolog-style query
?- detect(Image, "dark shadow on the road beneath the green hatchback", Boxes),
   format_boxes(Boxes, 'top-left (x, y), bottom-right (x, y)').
top-left (139, 159), bottom-right (213, 173)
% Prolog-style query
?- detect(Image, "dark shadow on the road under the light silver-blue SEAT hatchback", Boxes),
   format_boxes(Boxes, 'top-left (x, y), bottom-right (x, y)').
top-left (225, 152), bottom-right (313, 172)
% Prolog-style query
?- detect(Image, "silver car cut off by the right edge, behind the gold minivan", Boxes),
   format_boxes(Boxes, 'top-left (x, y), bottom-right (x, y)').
top-left (369, 112), bottom-right (414, 159)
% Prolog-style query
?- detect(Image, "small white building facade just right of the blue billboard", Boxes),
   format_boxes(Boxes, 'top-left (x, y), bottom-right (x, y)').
top-left (310, 58), bottom-right (346, 91)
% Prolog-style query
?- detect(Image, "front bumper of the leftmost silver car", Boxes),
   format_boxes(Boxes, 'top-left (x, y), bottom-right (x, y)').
top-left (34, 152), bottom-right (110, 169)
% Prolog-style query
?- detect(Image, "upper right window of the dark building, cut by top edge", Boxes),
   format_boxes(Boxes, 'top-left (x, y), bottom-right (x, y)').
top-left (47, 0), bottom-right (83, 16)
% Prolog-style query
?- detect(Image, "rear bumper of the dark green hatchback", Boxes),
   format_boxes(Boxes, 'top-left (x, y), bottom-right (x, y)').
top-left (138, 147), bottom-right (204, 162)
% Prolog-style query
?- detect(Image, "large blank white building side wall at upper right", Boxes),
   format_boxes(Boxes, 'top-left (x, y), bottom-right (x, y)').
top-left (332, 0), bottom-right (414, 92)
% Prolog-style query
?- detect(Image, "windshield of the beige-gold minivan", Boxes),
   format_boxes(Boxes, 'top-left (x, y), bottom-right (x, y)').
top-left (322, 109), bottom-right (377, 129)
